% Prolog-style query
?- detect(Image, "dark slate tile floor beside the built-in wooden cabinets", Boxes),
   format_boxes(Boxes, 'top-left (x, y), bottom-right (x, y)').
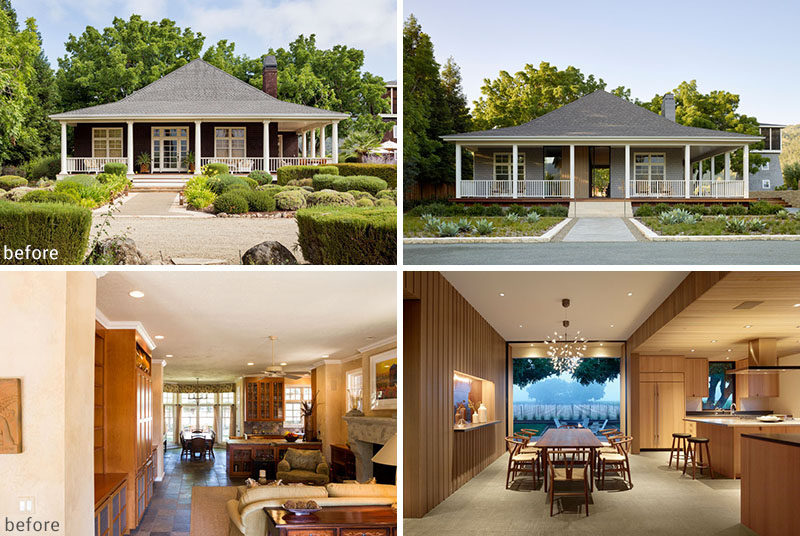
top-left (131, 449), bottom-right (243, 536)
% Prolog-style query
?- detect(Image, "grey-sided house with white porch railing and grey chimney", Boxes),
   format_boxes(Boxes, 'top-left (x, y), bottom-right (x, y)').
top-left (443, 91), bottom-right (761, 206)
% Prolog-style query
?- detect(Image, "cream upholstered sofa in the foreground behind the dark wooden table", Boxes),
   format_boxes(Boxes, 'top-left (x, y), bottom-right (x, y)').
top-left (225, 484), bottom-right (397, 536)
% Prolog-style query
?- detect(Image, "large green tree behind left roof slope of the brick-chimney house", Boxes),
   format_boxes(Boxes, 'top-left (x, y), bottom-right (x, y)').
top-left (56, 15), bottom-right (205, 110)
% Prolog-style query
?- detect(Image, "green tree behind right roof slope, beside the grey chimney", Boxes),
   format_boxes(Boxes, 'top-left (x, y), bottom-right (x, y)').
top-left (640, 80), bottom-right (767, 174)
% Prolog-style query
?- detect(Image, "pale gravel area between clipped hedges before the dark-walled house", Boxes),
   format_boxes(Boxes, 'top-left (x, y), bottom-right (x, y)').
top-left (92, 216), bottom-right (304, 264)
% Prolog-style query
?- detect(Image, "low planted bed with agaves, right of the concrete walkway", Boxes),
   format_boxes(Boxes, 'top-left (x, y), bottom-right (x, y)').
top-left (637, 216), bottom-right (800, 236)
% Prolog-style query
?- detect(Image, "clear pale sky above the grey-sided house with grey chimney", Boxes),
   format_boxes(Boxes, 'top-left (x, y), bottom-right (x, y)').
top-left (403, 0), bottom-right (800, 124)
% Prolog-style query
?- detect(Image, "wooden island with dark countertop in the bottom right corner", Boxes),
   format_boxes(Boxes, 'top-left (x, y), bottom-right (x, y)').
top-left (741, 429), bottom-right (800, 536)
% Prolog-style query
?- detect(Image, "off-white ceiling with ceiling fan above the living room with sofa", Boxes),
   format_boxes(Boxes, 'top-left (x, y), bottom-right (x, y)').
top-left (97, 271), bottom-right (397, 382)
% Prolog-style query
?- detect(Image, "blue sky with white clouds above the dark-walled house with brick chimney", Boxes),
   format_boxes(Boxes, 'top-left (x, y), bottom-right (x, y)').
top-left (11, 0), bottom-right (397, 80)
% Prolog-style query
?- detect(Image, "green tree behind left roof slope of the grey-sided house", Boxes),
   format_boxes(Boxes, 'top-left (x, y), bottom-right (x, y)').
top-left (473, 61), bottom-right (630, 130)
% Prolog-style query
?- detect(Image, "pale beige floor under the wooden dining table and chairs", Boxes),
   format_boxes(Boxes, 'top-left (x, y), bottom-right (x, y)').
top-left (403, 452), bottom-right (755, 536)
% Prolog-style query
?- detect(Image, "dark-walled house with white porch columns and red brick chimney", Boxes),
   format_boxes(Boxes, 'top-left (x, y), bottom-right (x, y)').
top-left (50, 56), bottom-right (349, 177)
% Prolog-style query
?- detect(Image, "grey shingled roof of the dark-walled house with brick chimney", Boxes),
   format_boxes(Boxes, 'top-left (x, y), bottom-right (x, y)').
top-left (50, 59), bottom-right (349, 120)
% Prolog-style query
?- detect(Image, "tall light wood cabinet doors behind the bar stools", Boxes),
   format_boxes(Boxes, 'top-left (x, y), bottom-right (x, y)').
top-left (639, 381), bottom-right (686, 449)
